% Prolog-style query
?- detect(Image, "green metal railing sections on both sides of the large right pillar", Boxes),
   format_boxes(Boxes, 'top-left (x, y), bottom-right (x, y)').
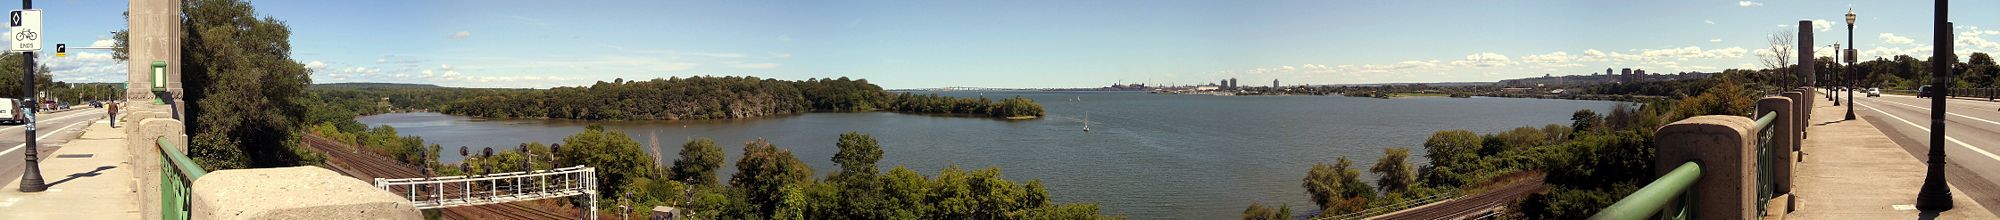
top-left (1590, 110), bottom-right (1778, 220)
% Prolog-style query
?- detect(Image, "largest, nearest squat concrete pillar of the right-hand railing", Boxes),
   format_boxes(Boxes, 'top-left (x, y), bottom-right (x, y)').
top-left (1654, 116), bottom-right (1756, 220)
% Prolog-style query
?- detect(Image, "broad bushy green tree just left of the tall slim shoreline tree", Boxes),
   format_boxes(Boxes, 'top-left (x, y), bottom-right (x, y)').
top-left (730, 138), bottom-right (812, 216)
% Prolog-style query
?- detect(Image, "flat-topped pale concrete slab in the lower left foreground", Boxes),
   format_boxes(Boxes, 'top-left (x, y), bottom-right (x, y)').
top-left (190, 166), bottom-right (424, 220)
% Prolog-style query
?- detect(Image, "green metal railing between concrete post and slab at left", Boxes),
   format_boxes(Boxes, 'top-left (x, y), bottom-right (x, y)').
top-left (158, 136), bottom-right (208, 220)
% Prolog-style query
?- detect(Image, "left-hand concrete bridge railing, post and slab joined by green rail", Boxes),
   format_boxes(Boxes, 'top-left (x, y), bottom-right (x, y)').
top-left (131, 110), bottom-right (424, 220)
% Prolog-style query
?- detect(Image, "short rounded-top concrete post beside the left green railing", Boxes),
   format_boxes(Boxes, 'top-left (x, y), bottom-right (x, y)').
top-left (126, 118), bottom-right (188, 218)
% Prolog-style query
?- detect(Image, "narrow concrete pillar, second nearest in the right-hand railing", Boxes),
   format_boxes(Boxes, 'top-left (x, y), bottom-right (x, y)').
top-left (1752, 96), bottom-right (1812, 210)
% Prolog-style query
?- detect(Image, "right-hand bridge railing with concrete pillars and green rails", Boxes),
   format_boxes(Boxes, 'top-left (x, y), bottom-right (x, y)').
top-left (1592, 88), bottom-right (1812, 220)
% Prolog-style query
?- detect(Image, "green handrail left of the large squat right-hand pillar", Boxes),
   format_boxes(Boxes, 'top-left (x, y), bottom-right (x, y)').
top-left (1590, 162), bottom-right (1702, 220)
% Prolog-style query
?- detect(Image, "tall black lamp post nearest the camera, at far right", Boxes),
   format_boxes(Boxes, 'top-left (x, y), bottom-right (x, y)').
top-left (1916, 0), bottom-right (1958, 212)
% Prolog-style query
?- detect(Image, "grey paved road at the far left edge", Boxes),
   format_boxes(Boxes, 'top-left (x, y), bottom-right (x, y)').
top-left (0, 108), bottom-right (107, 186)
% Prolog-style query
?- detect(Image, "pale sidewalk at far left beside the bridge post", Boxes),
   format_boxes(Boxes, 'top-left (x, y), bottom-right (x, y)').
top-left (0, 120), bottom-right (142, 220)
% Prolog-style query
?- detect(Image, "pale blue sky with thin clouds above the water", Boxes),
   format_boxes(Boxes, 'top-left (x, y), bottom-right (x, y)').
top-left (19, 0), bottom-right (2000, 88)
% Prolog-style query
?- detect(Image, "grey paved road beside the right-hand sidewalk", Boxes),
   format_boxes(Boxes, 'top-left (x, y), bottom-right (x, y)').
top-left (1840, 94), bottom-right (2000, 212)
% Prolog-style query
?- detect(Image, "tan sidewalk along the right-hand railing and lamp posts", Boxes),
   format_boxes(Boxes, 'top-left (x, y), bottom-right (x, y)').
top-left (1786, 94), bottom-right (2000, 220)
